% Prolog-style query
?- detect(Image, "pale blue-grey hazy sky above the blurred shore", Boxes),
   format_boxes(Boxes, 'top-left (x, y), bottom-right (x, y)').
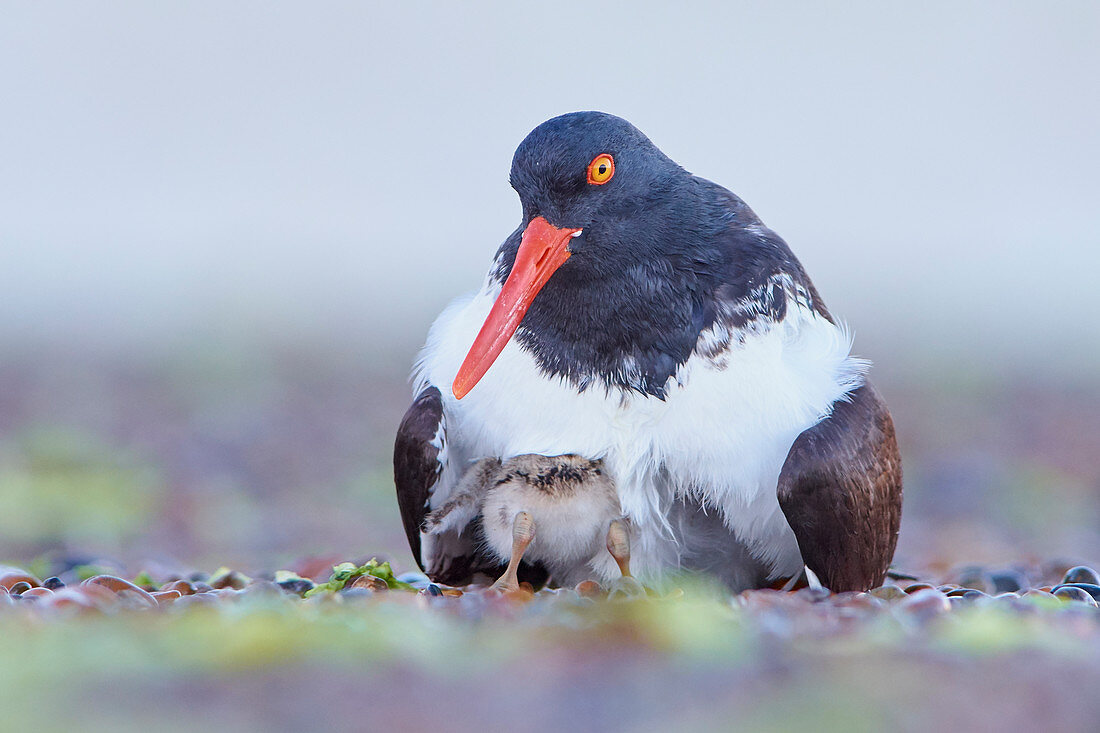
top-left (0, 0), bottom-right (1100, 374)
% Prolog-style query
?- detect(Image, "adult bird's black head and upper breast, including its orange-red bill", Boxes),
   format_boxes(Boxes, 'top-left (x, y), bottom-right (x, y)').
top-left (452, 112), bottom-right (809, 398)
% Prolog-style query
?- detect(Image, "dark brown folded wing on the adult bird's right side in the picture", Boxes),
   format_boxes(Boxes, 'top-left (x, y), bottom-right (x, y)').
top-left (779, 384), bottom-right (901, 592)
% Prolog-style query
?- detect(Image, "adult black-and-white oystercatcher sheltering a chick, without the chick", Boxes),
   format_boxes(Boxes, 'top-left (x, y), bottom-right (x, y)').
top-left (394, 112), bottom-right (902, 591)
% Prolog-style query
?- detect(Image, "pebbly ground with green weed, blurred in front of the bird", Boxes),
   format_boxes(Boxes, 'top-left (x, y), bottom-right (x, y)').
top-left (0, 554), bottom-right (1100, 732)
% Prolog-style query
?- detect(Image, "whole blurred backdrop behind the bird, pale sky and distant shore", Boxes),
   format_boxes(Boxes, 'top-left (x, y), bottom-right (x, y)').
top-left (0, 2), bottom-right (1100, 568)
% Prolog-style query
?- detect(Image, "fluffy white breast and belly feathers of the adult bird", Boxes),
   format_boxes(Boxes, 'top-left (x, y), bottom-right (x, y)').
top-left (417, 280), bottom-right (867, 579)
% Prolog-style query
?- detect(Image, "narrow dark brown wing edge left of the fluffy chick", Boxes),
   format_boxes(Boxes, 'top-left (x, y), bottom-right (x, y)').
top-left (394, 386), bottom-right (446, 570)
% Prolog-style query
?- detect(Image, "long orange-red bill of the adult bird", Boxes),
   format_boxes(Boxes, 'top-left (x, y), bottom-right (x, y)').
top-left (451, 217), bottom-right (581, 400)
